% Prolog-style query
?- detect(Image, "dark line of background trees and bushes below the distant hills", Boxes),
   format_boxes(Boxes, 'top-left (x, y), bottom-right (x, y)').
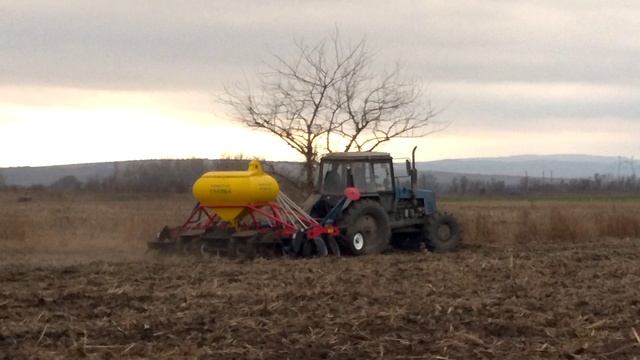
top-left (0, 160), bottom-right (640, 197)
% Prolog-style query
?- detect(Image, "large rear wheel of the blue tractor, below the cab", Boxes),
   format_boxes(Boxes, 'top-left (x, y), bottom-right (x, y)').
top-left (342, 200), bottom-right (391, 255)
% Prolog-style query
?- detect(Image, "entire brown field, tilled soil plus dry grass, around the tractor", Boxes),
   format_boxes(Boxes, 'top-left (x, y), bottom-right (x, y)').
top-left (0, 192), bottom-right (640, 359)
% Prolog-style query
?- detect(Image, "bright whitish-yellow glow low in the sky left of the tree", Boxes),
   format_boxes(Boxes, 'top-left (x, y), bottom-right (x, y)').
top-left (0, 88), bottom-right (296, 167)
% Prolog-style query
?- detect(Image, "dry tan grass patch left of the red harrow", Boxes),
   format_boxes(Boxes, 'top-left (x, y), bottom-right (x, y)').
top-left (0, 192), bottom-right (193, 262)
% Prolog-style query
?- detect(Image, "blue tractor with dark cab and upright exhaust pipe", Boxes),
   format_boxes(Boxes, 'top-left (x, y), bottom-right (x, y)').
top-left (304, 148), bottom-right (462, 255)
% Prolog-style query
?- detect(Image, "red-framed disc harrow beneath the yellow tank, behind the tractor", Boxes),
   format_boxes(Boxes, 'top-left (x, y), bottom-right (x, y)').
top-left (148, 192), bottom-right (340, 258)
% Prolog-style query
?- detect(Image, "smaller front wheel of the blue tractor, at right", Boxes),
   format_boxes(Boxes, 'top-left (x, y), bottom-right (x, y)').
top-left (424, 213), bottom-right (462, 252)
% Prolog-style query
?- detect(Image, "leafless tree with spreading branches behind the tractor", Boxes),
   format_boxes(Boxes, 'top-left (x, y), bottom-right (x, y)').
top-left (223, 32), bottom-right (436, 187)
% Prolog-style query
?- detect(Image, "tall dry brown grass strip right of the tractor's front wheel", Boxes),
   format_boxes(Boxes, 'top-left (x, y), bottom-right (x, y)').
top-left (441, 195), bottom-right (640, 244)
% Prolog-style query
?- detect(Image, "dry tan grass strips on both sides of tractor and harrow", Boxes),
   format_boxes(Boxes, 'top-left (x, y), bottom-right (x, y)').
top-left (0, 192), bottom-right (640, 261)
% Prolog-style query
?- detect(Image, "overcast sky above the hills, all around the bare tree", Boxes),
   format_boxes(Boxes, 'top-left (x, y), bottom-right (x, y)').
top-left (0, 0), bottom-right (640, 166)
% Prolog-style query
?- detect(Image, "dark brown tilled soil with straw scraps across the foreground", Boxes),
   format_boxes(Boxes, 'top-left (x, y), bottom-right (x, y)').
top-left (0, 239), bottom-right (640, 359)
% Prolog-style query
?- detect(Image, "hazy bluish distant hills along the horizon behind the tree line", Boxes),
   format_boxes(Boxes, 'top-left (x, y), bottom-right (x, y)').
top-left (0, 155), bottom-right (634, 186)
